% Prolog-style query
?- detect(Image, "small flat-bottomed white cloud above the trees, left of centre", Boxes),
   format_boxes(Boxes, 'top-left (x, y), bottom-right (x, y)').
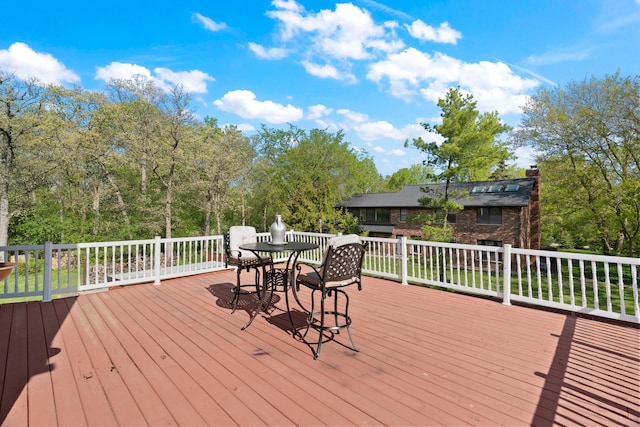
top-left (214, 90), bottom-right (303, 123)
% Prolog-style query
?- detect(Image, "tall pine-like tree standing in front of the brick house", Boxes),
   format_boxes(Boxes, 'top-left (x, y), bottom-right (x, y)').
top-left (405, 88), bottom-right (513, 240)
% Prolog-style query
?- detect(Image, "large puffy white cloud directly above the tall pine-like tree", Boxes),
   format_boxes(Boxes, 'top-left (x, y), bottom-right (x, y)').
top-left (367, 48), bottom-right (539, 114)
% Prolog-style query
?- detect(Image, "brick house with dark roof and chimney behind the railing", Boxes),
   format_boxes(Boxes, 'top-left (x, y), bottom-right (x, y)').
top-left (339, 168), bottom-right (540, 249)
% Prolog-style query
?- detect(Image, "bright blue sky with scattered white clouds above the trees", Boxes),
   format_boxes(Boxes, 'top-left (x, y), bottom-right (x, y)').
top-left (0, 0), bottom-right (640, 175)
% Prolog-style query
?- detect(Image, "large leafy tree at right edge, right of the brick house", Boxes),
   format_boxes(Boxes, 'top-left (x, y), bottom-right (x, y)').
top-left (514, 73), bottom-right (640, 256)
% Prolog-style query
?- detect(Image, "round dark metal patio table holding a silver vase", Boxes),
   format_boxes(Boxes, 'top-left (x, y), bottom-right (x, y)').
top-left (239, 242), bottom-right (319, 336)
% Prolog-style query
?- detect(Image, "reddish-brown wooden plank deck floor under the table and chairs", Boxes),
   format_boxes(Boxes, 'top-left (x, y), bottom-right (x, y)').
top-left (0, 272), bottom-right (640, 426)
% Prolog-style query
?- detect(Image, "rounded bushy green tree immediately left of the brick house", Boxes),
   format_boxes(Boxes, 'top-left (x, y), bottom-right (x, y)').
top-left (252, 126), bottom-right (381, 231)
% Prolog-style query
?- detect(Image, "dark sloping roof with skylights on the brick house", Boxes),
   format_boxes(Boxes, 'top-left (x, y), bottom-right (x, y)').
top-left (338, 178), bottom-right (536, 208)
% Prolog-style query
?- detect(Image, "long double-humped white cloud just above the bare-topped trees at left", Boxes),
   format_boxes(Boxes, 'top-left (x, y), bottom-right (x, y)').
top-left (95, 62), bottom-right (215, 93)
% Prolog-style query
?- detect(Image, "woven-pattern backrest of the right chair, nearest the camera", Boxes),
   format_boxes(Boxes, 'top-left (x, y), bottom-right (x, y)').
top-left (321, 234), bottom-right (365, 289)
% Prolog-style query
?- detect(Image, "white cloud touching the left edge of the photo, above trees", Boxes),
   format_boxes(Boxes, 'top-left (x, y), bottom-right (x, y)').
top-left (0, 42), bottom-right (80, 84)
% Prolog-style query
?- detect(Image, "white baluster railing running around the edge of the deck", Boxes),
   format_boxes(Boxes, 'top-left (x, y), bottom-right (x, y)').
top-left (0, 231), bottom-right (640, 323)
